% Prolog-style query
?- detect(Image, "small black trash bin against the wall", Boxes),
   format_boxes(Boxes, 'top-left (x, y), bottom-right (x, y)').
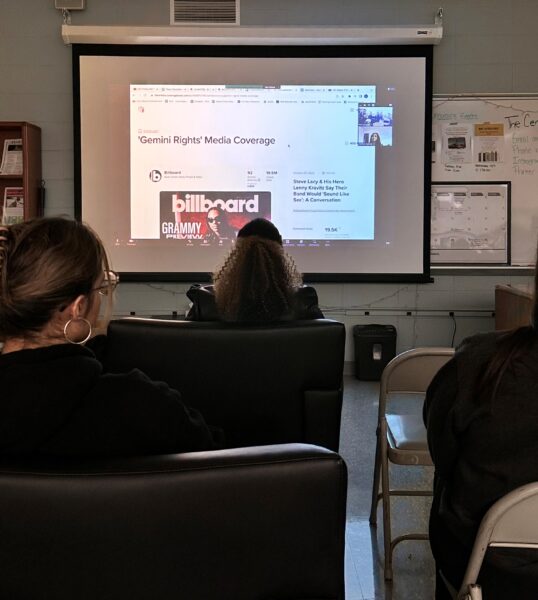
top-left (353, 325), bottom-right (396, 381)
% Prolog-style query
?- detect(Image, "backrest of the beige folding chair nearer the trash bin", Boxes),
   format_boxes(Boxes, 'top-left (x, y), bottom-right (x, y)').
top-left (379, 347), bottom-right (454, 414)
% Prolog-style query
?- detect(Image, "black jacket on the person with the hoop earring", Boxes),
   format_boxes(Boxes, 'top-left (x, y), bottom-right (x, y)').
top-left (0, 344), bottom-right (220, 456)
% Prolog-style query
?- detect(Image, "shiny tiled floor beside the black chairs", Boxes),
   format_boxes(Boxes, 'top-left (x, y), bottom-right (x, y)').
top-left (340, 376), bottom-right (434, 600)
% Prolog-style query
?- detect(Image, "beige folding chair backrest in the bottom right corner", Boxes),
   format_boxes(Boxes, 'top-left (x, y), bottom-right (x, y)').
top-left (458, 483), bottom-right (538, 598)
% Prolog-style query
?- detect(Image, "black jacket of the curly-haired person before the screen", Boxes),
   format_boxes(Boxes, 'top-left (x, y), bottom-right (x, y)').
top-left (185, 285), bottom-right (323, 321)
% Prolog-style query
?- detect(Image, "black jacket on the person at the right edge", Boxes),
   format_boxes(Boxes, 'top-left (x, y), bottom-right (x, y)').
top-left (424, 333), bottom-right (538, 600)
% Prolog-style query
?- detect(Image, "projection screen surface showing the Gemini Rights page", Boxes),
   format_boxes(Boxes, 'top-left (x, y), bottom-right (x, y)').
top-left (75, 47), bottom-right (429, 280)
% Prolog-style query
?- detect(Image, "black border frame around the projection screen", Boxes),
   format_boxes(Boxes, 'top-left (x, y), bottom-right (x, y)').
top-left (72, 44), bottom-right (433, 283)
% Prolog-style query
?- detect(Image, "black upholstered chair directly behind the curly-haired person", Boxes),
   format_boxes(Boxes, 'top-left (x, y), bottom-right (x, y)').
top-left (101, 318), bottom-right (345, 451)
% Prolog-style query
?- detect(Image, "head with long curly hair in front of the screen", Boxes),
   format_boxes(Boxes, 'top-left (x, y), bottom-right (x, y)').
top-left (213, 219), bottom-right (302, 322)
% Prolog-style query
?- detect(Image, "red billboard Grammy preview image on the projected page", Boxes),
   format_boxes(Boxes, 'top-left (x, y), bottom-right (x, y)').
top-left (160, 191), bottom-right (271, 245)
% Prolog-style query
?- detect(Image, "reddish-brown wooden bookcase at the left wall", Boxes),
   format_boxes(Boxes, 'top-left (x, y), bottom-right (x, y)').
top-left (0, 121), bottom-right (44, 223)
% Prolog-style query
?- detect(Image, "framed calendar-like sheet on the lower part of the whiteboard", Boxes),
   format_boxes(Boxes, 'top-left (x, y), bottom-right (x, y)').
top-left (430, 181), bottom-right (511, 265)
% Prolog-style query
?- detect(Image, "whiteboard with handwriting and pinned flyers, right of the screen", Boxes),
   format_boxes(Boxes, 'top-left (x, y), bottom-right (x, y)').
top-left (432, 95), bottom-right (538, 266)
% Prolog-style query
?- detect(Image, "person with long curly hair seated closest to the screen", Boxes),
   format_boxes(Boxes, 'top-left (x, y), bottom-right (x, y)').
top-left (186, 219), bottom-right (323, 323)
